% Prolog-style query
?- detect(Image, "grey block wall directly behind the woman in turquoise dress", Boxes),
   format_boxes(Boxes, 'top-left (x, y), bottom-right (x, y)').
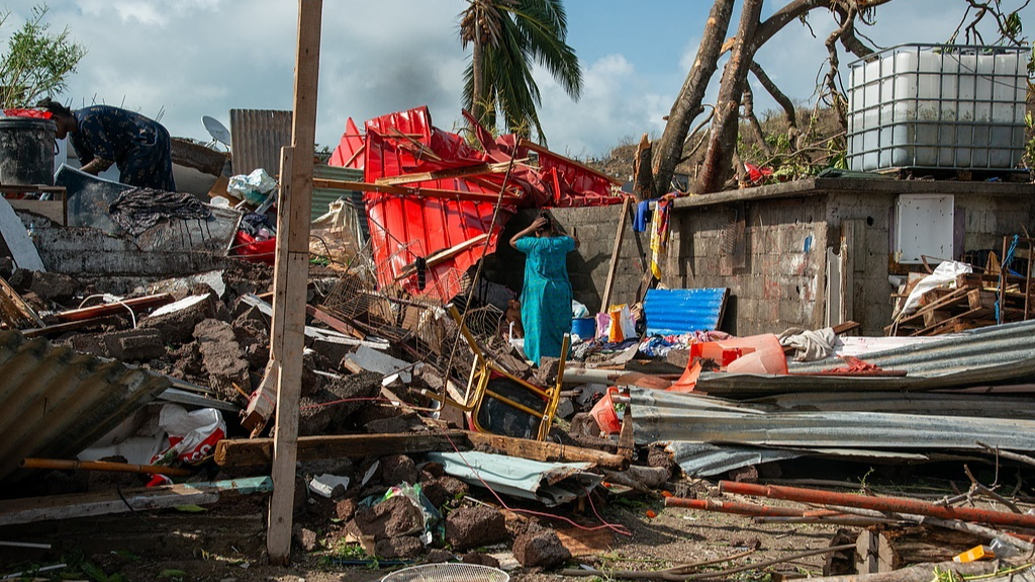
top-left (488, 204), bottom-right (649, 312)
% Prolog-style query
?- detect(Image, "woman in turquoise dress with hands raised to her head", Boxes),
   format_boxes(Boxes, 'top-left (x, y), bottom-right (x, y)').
top-left (510, 212), bottom-right (579, 366)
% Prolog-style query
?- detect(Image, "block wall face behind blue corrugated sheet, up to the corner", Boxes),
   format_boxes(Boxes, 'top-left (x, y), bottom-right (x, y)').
top-left (661, 198), bottom-right (827, 336)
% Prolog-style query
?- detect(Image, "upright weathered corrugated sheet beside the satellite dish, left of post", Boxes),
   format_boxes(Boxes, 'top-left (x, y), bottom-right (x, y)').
top-left (230, 109), bottom-right (292, 176)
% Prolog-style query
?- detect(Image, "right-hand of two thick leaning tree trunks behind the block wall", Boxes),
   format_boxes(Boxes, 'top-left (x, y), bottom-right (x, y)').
top-left (696, 0), bottom-right (763, 194)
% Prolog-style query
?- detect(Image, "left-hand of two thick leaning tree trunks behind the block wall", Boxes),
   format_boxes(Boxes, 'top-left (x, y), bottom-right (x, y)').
top-left (651, 0), bottom-right (736, 197)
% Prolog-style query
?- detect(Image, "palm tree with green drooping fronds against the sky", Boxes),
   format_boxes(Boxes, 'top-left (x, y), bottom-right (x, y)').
top-left (460, 0), bottom-right (582, 143)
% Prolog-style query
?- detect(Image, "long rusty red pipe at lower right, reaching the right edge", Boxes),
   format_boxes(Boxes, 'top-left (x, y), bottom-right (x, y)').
top-left (718, 481), bottom-right (1035, 527)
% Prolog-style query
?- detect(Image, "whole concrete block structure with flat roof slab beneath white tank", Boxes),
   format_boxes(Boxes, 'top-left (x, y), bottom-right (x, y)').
top-left (662, 180), bottom-right (1035, 336)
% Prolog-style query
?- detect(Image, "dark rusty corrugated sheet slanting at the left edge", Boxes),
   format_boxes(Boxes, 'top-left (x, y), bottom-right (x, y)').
top-left (0, 330), bottom-right (170, 481)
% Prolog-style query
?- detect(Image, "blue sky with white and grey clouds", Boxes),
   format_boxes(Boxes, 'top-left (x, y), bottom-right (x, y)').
top-left (0, 0), bottom-right (1035, 157)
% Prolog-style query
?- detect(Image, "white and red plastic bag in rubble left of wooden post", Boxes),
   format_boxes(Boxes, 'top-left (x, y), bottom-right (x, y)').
top-left (151, 404), bottom-right (227, 464)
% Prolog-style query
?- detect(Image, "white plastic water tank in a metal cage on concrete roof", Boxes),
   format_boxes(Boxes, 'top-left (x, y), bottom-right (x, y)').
top-left (848, 45), bottom-right (1028, 171)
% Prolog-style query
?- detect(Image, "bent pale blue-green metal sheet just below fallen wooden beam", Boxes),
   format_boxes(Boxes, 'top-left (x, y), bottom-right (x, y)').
top-left (425, 445), bottom-right (603, 507)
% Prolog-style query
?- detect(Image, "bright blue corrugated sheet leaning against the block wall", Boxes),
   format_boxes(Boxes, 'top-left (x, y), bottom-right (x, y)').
top-left (644, 287), bottom-right (730, 336)
